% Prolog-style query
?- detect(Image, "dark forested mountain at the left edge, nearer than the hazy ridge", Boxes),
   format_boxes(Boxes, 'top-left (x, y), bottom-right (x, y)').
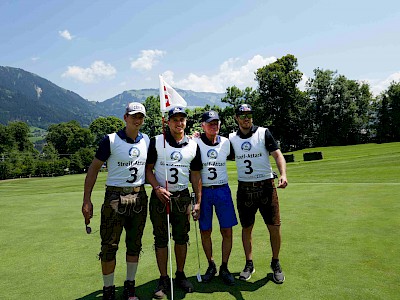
top-left (0, 66), bottom-right (99, 128)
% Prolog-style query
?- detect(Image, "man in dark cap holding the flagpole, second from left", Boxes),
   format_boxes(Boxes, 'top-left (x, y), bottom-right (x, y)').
top-left (146, 107), bottom-right (202, 299)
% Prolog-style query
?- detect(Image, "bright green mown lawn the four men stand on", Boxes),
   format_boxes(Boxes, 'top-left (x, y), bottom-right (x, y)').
top-left (0, 143), bottom-right (400, 300)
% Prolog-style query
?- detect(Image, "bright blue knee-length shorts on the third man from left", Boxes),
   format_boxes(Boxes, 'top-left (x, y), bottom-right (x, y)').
top-left (199, 184), bottom-right (238, 231)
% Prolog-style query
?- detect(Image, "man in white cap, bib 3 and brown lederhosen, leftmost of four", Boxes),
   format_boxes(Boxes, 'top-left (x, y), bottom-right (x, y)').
top-left (82, 102), bottom-right (150, 300)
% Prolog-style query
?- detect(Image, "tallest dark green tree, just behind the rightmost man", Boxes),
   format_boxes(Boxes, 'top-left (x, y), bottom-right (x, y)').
top-left (253, 54), bottom-right (306, 151)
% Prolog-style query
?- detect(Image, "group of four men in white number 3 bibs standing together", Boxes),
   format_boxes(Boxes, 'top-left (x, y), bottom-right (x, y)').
top-left (82, 102), bottom-right (287, 300)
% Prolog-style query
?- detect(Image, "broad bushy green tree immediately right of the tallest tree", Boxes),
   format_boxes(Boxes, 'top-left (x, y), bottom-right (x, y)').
top-left (307, 69), bottom-right (372, 146)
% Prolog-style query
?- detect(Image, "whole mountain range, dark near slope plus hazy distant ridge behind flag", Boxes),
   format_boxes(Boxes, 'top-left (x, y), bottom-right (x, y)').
top-left (0, 66), bottom-right (226, 129)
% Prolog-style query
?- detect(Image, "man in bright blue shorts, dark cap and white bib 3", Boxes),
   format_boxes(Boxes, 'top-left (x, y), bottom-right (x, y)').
top-left (195, 110), bottom-right (238, 285)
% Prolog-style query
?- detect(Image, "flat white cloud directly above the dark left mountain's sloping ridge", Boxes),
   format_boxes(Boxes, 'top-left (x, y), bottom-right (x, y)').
top-left (61, 60), bottom-right (117, 83)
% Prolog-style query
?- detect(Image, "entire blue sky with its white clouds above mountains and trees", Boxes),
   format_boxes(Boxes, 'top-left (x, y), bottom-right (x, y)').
top-left (0, 0), bottom-right (400, 101)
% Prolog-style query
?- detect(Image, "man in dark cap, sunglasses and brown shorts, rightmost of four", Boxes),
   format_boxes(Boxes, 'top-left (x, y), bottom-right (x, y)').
top-left (229, 104), bottom-right (288, 283)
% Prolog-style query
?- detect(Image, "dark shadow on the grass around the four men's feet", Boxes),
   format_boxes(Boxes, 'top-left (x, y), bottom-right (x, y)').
top-left (77, 273), bottom-right (273, 300)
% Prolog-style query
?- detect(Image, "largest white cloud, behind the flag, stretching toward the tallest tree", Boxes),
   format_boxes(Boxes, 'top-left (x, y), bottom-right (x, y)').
top-left (164, 55), bottom-right (276, 93)
